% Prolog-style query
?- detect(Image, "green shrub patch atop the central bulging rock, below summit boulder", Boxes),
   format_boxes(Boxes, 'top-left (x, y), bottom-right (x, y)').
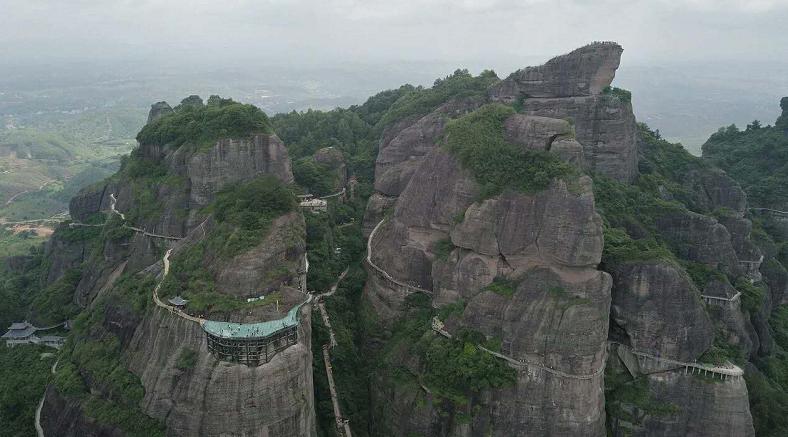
top-left (444, 104), bottom-right (577, 198)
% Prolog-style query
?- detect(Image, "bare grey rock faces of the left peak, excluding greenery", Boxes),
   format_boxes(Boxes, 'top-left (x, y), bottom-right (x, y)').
top-left (43, 96), bottom-right (316, 437)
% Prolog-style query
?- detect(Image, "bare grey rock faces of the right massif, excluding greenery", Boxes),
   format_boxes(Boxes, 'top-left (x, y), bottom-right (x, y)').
top-left (364, 43), bottom-right (764, 436)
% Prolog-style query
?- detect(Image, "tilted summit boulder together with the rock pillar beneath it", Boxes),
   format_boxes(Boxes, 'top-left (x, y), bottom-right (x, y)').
top-left (489, 43), bottom-right (637, 182)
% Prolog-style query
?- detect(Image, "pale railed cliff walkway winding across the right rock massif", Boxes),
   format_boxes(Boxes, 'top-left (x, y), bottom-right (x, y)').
top-left (366, 219), bottom-right (744, 380)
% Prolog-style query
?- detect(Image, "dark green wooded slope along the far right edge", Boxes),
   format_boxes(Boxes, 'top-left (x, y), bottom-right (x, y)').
top-left (703, 98), bottom-right (788, 436)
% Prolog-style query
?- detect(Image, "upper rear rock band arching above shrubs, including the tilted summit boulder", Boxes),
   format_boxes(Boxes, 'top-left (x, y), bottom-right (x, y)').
top-left (365, 43), bottom-right (637, 237)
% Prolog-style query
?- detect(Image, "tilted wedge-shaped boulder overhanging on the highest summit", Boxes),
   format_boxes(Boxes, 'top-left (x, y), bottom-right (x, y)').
top-left (490, 42), bottom-right (624, 99)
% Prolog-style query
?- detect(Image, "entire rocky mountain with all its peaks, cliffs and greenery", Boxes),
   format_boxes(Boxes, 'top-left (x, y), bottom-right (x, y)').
top-left (3, 42), bottom-right (788, 437)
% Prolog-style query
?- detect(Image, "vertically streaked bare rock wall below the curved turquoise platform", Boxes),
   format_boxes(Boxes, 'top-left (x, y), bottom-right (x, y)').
top-left (129, 306), bottom-right (315, 437)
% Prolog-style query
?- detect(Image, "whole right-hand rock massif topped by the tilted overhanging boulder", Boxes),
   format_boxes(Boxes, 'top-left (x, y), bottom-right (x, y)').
top-left (365, 43), bottom-right (760, 436)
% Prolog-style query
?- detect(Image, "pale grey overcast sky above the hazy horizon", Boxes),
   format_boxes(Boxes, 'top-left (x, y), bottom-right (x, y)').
top-left (0, 0), bottom-right (788, 73)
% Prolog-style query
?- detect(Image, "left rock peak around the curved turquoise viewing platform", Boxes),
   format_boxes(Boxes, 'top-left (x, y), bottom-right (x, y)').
top-left (36, 96), bottom-right (315, 436)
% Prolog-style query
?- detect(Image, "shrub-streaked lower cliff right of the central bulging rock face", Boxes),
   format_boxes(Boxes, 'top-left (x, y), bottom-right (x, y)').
top-left (595, 126), bottom-right (760, 436)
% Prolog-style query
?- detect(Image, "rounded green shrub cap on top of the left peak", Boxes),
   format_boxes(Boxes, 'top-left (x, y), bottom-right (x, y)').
top-left (137, 98), bottom-right (272, 148)
